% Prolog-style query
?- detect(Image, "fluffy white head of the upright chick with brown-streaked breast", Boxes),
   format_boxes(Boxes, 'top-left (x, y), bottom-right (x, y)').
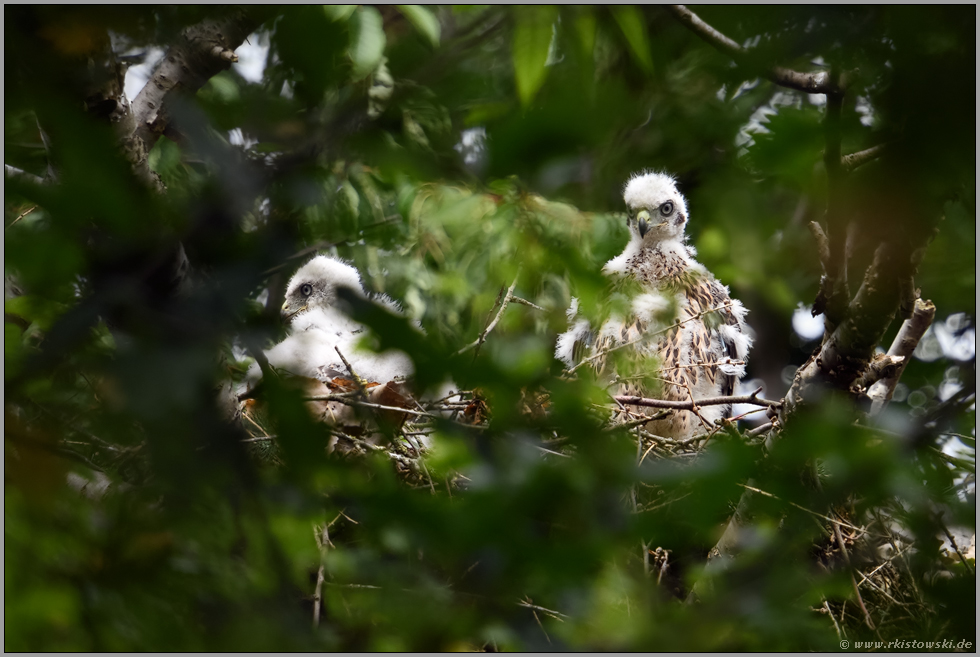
top-left (623, 173), bottom-right (688, 243)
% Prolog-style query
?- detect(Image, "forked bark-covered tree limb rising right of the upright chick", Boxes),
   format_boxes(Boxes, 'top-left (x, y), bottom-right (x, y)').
top-left (670, 5), bottom-right (935, 600)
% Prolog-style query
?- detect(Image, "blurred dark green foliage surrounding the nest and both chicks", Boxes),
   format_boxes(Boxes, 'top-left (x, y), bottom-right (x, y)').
top-left (4, 6), bottom-right (976, 651)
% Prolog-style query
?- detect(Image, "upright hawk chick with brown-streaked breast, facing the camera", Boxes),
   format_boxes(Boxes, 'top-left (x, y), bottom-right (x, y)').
top-left (555, 173), bottom-right (752, 438)
